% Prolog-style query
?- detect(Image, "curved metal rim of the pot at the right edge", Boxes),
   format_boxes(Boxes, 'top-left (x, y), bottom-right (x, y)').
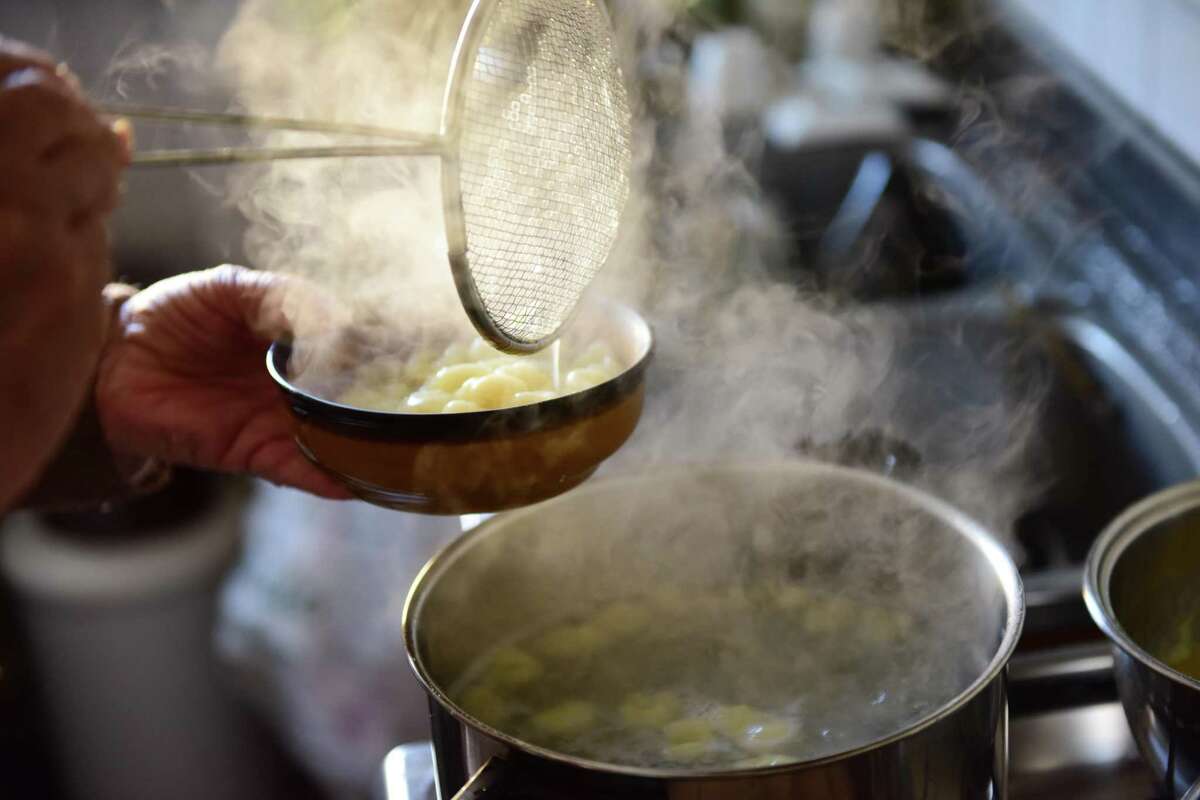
top-left (1084, 480), bottom-right (1200, 691)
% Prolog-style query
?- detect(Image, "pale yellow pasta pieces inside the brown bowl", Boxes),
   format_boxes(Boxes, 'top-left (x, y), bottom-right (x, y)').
top-left (337, 338), bottom-right (620, 414)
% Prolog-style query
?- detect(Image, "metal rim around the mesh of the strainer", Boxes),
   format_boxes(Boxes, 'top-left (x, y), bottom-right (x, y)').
top-left (440, 0), bottom-right (628, 354)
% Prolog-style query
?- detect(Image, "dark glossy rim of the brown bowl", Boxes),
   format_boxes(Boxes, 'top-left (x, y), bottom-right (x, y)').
top-left (266, 301), bottom-right (654, 441)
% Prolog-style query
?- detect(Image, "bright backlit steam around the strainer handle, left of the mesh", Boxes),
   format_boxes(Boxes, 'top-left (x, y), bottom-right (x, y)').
top-left (217, 0), bottom-right (467, 339)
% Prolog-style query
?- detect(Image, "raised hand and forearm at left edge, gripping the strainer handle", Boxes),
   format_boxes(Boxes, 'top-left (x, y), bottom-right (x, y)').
top-left (0, 37), bottom-right (130, 509)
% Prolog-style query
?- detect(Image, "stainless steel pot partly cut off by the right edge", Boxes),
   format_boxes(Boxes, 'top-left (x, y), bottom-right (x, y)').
top-left (1084, 481), bottom-right (1200, 798)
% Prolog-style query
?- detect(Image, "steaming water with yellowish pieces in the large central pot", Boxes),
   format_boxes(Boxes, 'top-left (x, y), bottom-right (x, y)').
top-left (451, 585), bottom-right (985, 768)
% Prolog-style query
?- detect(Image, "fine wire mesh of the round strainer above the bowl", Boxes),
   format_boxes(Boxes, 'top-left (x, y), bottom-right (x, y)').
top-left (460, 0), bottom-right (631, 343)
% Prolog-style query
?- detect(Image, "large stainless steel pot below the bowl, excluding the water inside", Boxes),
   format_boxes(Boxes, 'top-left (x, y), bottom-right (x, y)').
top-left (404, 463), bottom-right (1024, 800)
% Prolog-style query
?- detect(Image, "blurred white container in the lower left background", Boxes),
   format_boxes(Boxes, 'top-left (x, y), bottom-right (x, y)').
top-left (0, 479), bottom-right (288, 800)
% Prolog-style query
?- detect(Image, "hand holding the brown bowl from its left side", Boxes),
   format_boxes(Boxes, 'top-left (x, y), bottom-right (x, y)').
top-left (96, 265), bottom-right (349, 499)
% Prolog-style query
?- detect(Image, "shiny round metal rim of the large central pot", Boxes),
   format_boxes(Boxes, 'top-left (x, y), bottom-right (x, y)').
top-left (402, 459), bottom-right (1025, 780)
